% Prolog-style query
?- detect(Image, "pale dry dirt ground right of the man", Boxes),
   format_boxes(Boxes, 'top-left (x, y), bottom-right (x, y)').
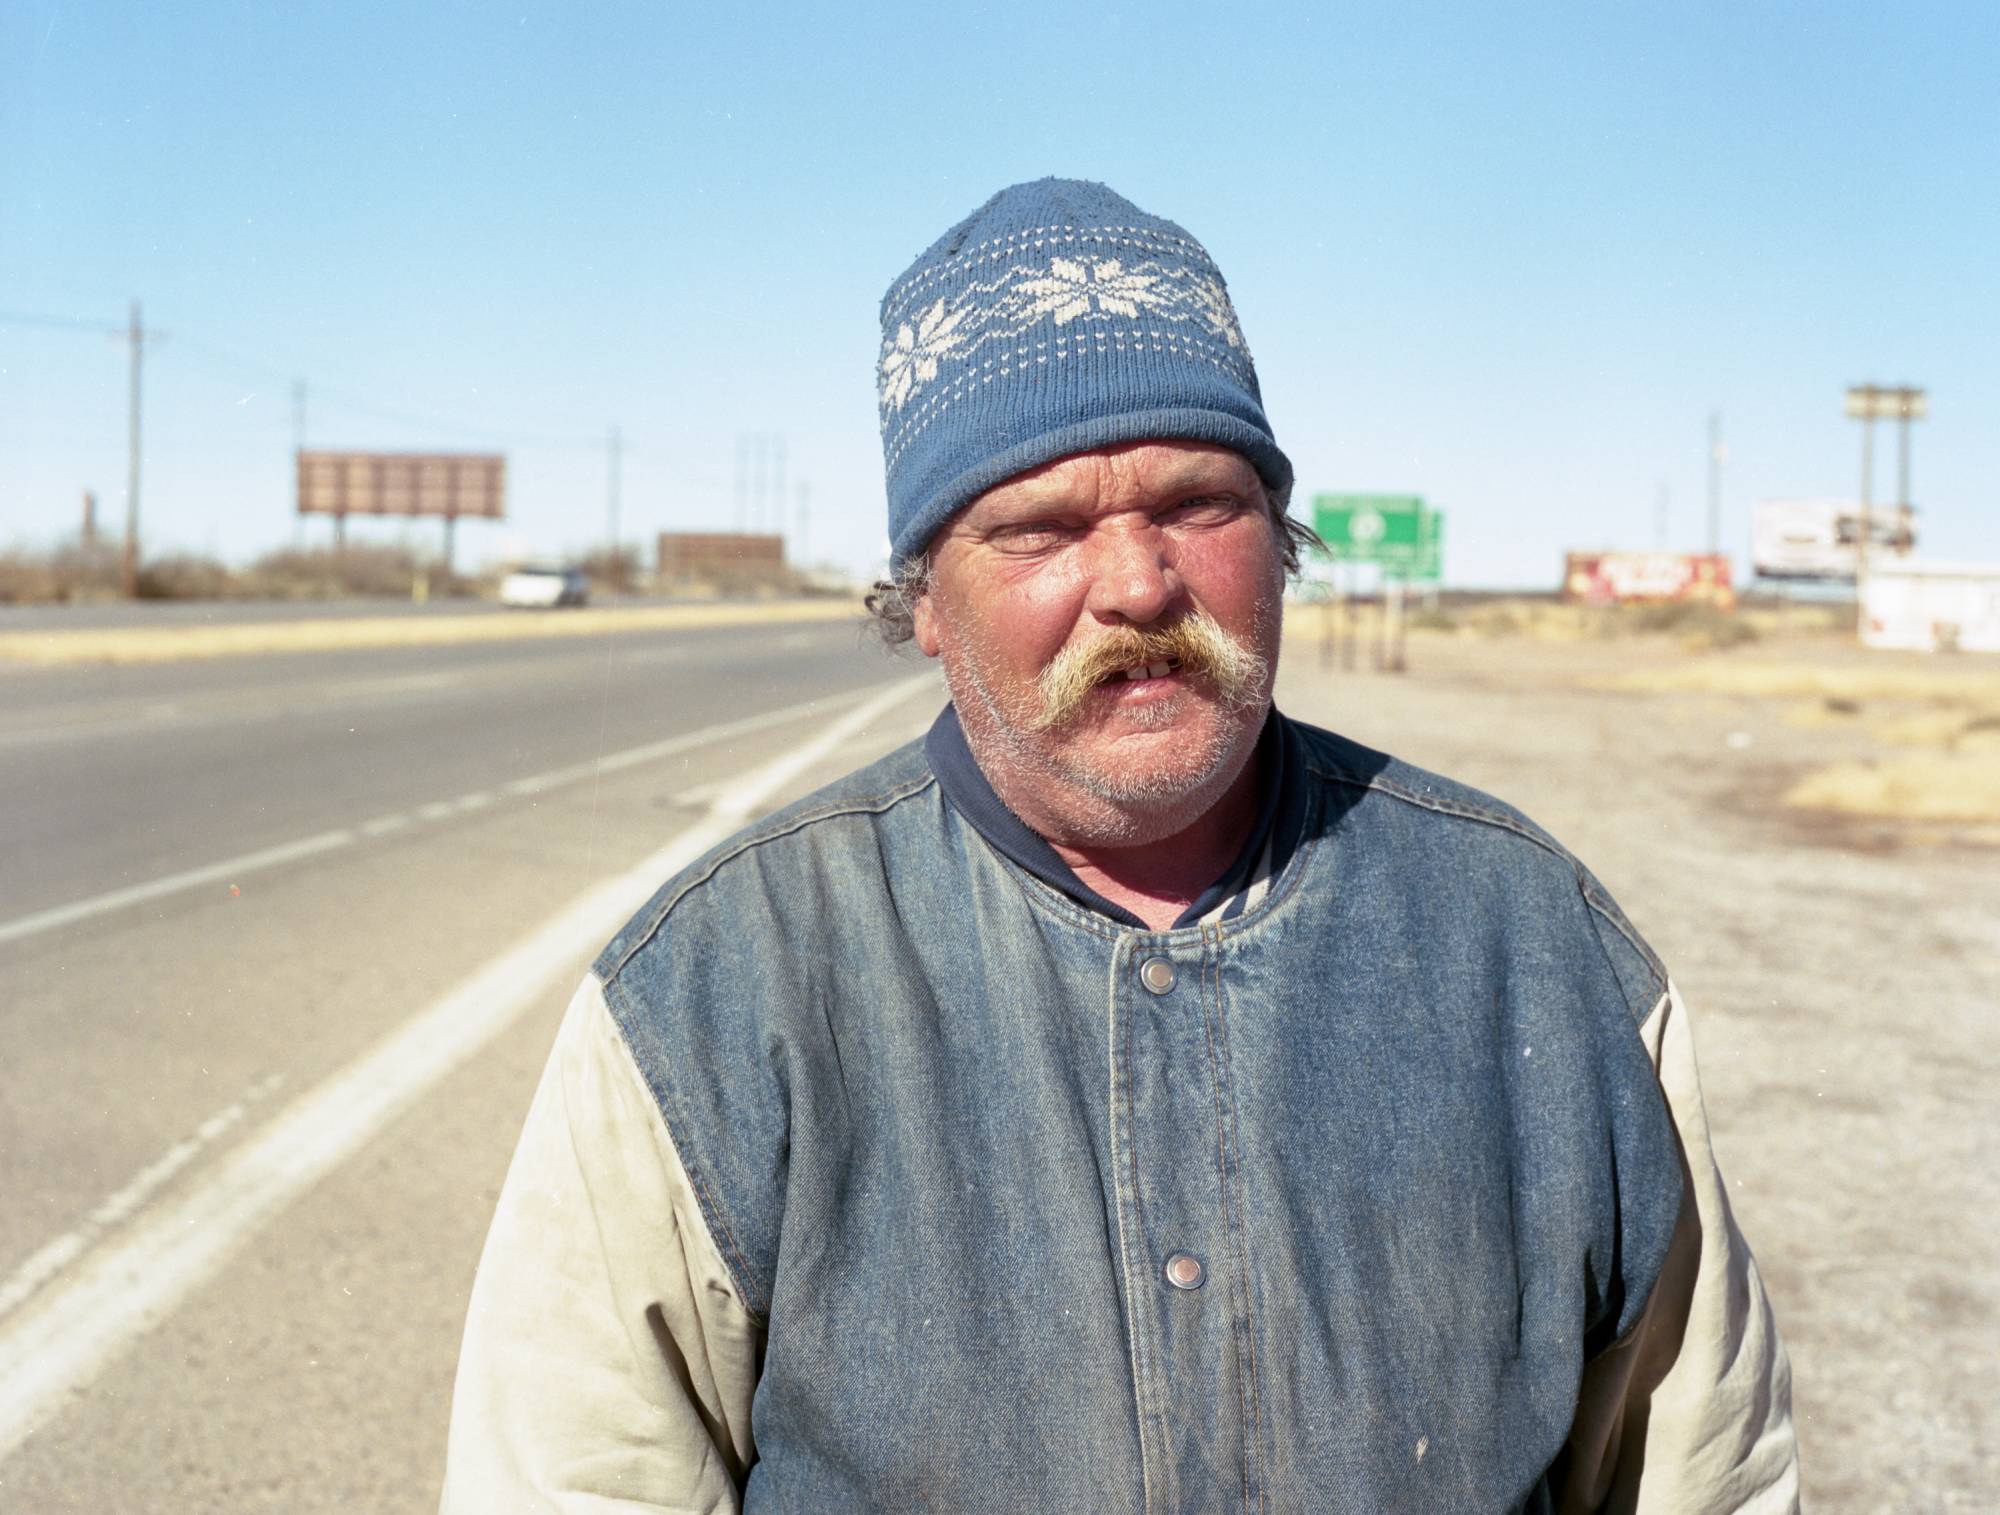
top-left (1278, 634), bottom-right (2000, 1515)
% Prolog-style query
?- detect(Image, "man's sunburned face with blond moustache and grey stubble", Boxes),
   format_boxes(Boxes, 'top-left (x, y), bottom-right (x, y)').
top-left (916, 442), bottom-right (1284, 845)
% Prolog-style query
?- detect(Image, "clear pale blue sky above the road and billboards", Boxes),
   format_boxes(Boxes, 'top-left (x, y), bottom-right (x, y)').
top-left (0, 0), bottom-right (2000, 586)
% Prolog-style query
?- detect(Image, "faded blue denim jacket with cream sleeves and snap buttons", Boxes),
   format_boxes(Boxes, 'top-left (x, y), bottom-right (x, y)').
top-left (444, 724), bottom-right (1796, 1515)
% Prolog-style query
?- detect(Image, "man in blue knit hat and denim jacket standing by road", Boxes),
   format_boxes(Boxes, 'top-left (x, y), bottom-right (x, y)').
top-left (444, 180), bottom-right (1796, 1515)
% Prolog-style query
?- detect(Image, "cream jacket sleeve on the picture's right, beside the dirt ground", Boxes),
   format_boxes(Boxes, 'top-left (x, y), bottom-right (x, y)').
top-left (1560, 985), bottom-right (1798, 1515)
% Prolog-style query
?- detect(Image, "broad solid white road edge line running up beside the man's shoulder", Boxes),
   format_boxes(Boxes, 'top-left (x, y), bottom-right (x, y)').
top-left (0, 676), bottom-right (934, 1459)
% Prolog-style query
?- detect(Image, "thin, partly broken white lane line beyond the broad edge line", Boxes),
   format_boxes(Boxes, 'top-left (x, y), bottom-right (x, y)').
top-left (0, 700), bottom-right (900, 945)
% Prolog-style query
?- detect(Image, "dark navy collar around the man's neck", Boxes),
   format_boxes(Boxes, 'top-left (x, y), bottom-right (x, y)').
top-left (924, 706), bottom-right (1306, 931)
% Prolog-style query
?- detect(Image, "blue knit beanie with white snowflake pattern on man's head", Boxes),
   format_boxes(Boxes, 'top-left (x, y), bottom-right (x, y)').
top-left (876, 178), bottom-right (1292, 570)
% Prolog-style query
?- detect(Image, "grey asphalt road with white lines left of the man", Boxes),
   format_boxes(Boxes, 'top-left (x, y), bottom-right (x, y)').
top-left (0, 624), bottom-right (942, 1511)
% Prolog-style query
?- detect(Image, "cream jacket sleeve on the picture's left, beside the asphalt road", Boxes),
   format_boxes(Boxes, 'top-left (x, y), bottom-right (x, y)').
top-left (442, 979), bottom-right (764, 1515)
